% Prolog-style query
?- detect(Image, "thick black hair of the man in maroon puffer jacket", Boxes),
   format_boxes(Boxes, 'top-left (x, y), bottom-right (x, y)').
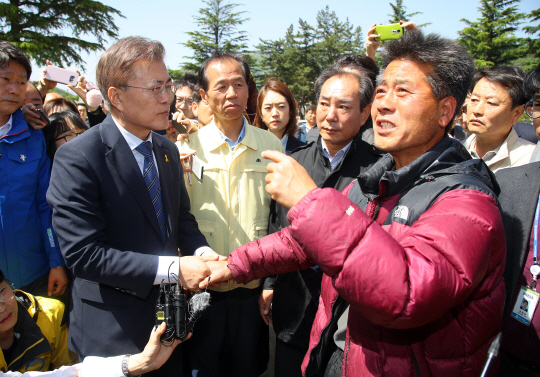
top-left (378, 31), bottom-right (475, 128)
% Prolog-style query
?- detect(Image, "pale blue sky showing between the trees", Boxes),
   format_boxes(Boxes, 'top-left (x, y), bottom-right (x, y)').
top-left (26, 0), bottom-right (538, 89)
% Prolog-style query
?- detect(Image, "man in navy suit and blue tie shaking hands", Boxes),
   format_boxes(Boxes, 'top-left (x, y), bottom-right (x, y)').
top-left (47, 37), bottom-right (212, 375)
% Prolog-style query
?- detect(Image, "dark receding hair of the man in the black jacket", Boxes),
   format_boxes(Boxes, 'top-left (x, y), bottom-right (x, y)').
top-left (312, 55), bottom-right (379, 111)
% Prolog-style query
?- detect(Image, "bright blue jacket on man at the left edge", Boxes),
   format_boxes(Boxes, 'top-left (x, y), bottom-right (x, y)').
top-left (0, 110), bottom-right (65, 287)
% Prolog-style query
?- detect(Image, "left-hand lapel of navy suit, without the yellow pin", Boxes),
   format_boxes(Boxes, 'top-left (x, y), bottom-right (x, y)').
top-left (100, 115), bottom-right (161, 238)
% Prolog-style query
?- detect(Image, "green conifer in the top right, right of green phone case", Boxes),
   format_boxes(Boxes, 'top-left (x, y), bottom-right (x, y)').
top-left (458, 0), bottom-right (528, 67)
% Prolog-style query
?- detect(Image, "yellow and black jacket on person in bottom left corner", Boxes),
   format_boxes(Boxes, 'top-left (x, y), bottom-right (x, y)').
top-left (0, 290), bottom-right (78, 373)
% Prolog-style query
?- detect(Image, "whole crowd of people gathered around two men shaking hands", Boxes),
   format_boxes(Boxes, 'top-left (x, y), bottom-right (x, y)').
top-left (0, 22), bottom-right (540, 377)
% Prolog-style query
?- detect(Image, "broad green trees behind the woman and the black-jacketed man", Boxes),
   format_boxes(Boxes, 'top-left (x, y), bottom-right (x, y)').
top-left (255, 6), bottom-right (364, 107)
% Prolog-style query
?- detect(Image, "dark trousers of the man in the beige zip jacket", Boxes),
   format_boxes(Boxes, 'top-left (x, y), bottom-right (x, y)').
top-left (186, 288), bottom-right (266, 377)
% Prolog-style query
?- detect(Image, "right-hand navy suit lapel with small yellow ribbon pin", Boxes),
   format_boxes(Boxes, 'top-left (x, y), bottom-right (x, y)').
top-left (152, 133), bottom-right (174, 238)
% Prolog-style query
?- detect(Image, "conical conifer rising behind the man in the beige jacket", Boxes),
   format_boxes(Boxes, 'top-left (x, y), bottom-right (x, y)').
top-left (182, 0), bottom-right (249, 72)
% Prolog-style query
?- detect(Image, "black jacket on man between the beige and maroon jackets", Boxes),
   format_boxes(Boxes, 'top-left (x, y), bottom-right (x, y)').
top-left (264, 121), bottom-right (384, 349)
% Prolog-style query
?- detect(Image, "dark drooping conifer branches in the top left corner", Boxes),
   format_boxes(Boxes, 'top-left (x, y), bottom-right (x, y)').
top-left (0, 0), bottom-right (124, 66)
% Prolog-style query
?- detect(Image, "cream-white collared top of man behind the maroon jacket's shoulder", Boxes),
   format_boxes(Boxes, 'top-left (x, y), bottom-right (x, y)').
top-left (463, 128), bottom-right (535, 173)
